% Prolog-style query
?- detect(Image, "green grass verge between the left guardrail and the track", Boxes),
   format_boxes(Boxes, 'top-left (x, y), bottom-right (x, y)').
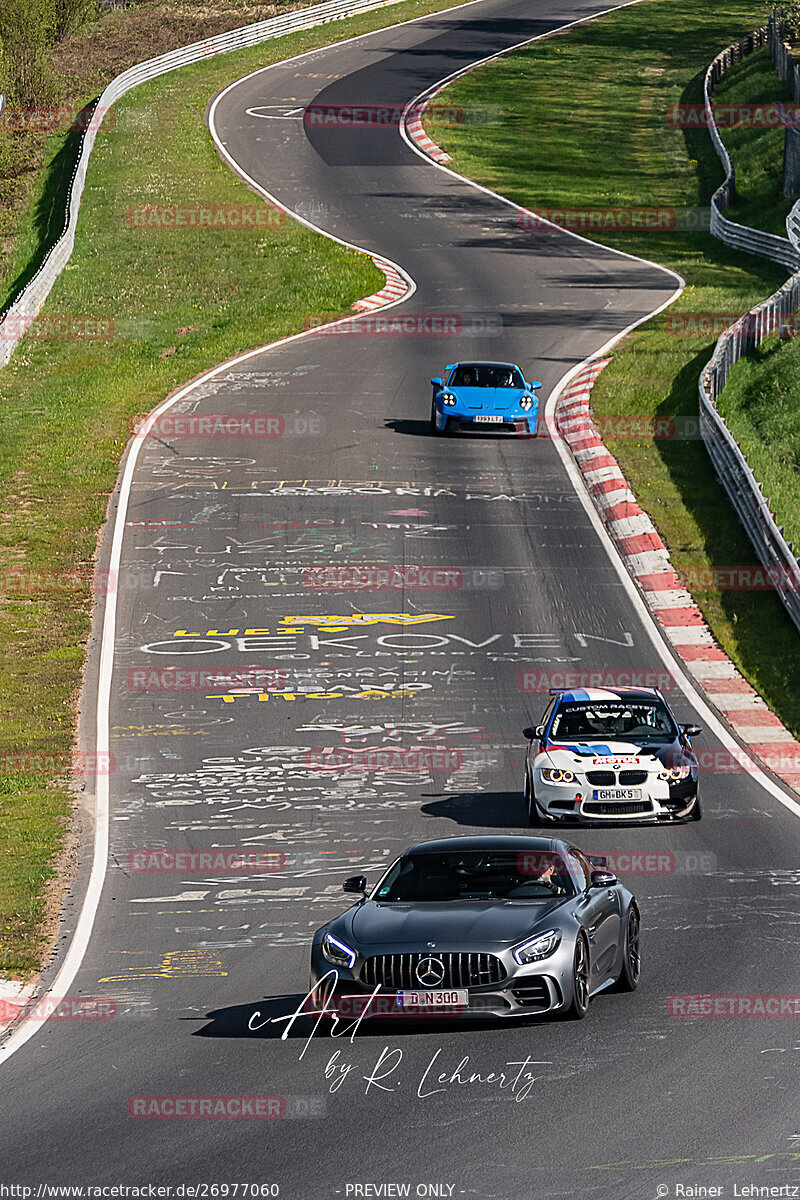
top-left (0, 0), bottom-right (470, 976)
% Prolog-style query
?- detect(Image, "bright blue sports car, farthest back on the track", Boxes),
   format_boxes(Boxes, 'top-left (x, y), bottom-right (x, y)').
top-left (431, 362), bottom-right (542, 438)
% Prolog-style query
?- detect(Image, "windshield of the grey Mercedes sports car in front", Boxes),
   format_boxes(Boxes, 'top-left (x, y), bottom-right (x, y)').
top-left (372, 850), bottom-right (576, 904)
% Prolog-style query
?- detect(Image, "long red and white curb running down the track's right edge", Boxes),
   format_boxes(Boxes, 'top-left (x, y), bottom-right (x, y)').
top-left (555, 358), bottom-right (800, 792)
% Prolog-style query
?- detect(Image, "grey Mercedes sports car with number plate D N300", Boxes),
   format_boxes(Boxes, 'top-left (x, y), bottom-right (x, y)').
top-left (309, 836), bottom-right (640, 1019)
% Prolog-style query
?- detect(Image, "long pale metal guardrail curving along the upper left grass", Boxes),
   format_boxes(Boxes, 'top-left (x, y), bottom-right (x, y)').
top-left (0, 0), bottom-right (412, 366)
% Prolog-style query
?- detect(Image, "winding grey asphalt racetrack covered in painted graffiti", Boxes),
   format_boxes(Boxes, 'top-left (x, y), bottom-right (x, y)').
top-left (0, 0), bottom-right (800, 1200)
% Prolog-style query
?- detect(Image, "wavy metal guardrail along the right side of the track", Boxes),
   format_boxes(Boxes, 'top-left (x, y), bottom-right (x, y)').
top-left (699, 23), bottom-right (800, 629)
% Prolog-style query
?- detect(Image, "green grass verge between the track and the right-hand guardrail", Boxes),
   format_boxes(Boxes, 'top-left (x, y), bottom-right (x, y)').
top-left (431, 0), bottom-right (800, 733)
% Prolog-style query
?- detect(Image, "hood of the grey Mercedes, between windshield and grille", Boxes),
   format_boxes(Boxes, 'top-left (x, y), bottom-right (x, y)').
top-left (353, 898), bottom-right (564, 950)
